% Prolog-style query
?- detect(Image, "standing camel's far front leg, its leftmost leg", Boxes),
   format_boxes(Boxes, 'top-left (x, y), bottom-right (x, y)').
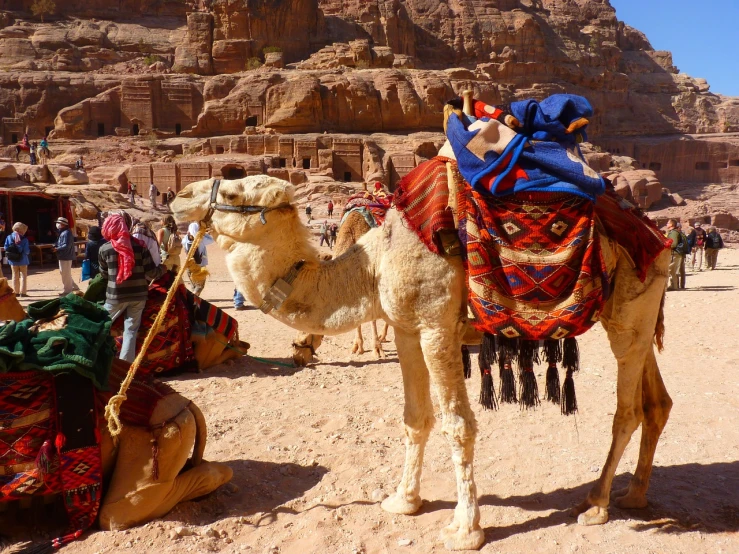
top-left (382, 333), bottom-right (434, 514)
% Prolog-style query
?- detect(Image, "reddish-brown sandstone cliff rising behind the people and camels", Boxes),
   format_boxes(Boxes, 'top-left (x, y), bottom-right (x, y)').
top-left (0, 0), bottom-right (739, 192)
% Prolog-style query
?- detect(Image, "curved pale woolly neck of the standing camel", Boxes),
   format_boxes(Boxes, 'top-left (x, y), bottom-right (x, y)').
top-left (219, 214), bottom-right (379, 334)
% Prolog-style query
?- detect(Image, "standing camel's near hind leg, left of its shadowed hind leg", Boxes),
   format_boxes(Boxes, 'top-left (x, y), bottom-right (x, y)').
top-left (573, 331), bottom-right (652, 525)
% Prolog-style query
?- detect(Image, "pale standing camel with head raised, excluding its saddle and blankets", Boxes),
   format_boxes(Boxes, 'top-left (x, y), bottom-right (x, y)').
top-left (172, 175), bottom-right (672, 550)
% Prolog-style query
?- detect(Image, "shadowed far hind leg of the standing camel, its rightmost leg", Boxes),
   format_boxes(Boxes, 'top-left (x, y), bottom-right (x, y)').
top-left (613, 349), bottom-right (672, 509)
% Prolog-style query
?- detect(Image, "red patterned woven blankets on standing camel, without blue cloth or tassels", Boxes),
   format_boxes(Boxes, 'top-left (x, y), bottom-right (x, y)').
top-left (396, 157), bottom-right (665, 340)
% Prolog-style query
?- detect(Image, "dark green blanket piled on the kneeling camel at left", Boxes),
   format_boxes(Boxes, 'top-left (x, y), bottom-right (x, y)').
top-left (0, 294), bottom-right (115, 390)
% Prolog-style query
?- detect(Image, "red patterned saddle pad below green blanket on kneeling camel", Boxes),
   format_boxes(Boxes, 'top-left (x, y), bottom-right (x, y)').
top-left (0, 370), bottom-right (103, 534)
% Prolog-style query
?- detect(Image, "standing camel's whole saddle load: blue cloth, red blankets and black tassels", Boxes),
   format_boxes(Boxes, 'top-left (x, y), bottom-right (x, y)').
top-left (395, 95), bottom-right (665, 414)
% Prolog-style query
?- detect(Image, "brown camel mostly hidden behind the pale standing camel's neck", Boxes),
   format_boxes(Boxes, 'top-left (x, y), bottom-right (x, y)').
top-left (292, 207), bottom-right (390, 367)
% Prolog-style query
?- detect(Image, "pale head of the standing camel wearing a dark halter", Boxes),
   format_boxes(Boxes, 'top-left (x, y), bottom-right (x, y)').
top-left (170, 175), bottom-right (297, 242)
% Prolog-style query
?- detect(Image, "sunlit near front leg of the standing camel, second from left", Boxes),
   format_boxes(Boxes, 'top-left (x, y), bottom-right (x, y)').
top-left (421, 329), bottom-right (485, 550)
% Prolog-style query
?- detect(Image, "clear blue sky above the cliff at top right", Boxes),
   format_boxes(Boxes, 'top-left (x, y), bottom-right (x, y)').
top-left (610, 0), bottom-right (739, 96)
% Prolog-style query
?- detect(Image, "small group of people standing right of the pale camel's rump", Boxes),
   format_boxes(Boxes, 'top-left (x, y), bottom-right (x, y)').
top-left (665, 219), bottom-right (724, 290)
